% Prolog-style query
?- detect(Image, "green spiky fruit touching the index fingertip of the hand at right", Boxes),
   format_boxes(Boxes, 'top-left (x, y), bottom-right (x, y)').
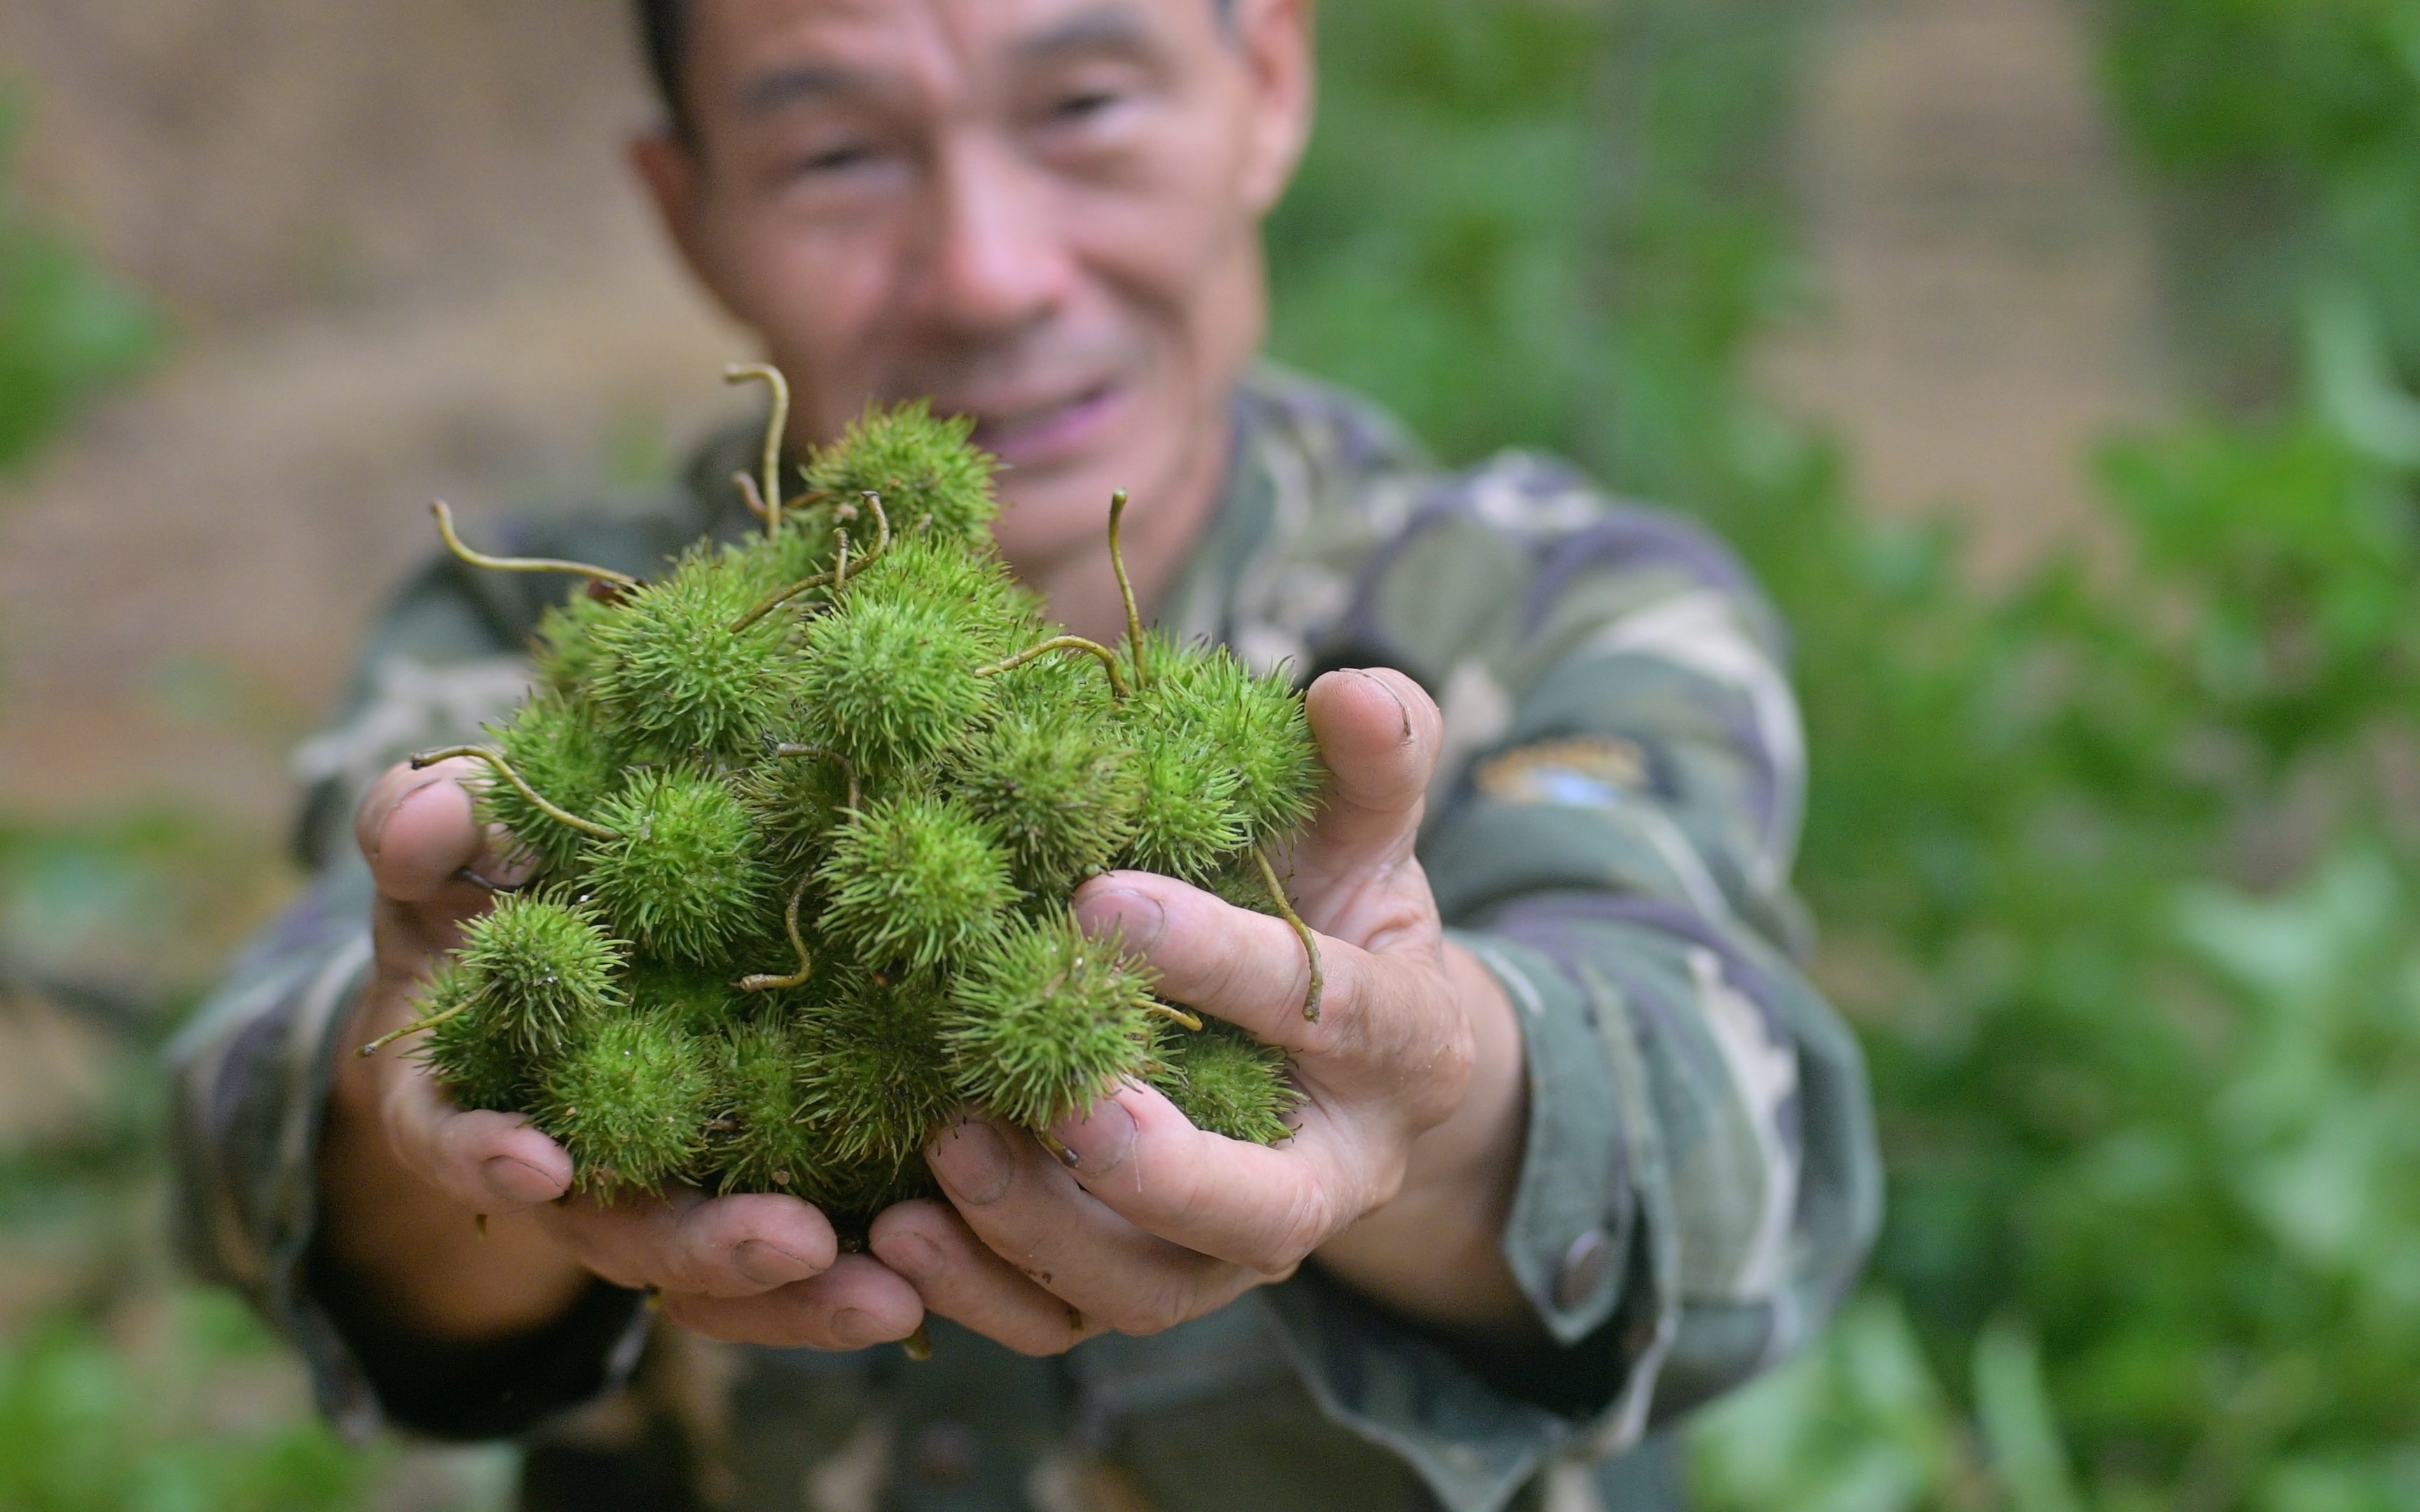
top-left (941, 912), bottom-right (1157, 1130)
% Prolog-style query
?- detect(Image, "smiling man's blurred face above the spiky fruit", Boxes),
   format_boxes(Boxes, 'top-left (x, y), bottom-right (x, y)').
top-left (639, 0), bottom-right (1309, 564)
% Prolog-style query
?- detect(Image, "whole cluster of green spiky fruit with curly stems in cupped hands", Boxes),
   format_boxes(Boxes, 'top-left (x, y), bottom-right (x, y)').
top-left (373, 368), bottom-right (1323, 1224)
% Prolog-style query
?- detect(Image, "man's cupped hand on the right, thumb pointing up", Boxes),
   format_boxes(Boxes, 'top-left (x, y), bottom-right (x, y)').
top-left (871, 670), bottom-right (1524, 1354)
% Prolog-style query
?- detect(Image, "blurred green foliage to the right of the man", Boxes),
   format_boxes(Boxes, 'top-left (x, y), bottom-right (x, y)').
top-left (1275, 0), bottom-right (2420, 1512)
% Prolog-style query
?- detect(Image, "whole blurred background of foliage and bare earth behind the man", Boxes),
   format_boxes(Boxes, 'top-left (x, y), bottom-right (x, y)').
top-left (0, 0), bottom-right (2420, 1512)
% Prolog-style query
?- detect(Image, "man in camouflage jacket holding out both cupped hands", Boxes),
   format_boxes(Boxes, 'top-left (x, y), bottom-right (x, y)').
top-left (179, 0), bottom-right (1878, 1512)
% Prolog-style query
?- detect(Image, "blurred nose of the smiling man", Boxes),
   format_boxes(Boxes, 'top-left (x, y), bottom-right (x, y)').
top-left (917, 143), bottom-right (1072, 344)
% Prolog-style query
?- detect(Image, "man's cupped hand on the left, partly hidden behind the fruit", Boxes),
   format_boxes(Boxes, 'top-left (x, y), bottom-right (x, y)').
top-left (319, 760), bottom-right (922, 1350)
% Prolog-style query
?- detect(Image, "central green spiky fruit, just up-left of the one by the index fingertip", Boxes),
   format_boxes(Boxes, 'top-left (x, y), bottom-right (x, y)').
top-left (816, 794), bottom-right (1017, 967)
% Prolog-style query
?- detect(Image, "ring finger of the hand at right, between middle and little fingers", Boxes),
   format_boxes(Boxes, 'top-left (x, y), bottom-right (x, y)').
top-left (927, 1120), bottom-right (1253, 1333)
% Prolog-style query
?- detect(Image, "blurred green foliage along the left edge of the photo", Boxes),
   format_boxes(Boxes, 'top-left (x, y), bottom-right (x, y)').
top-left (0, 97), bottom-right (380, 1512)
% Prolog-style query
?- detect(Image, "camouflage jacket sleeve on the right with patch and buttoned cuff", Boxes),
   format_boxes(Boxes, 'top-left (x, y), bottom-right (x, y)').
top-left (1273, 455), bottom-right (1880, 1512)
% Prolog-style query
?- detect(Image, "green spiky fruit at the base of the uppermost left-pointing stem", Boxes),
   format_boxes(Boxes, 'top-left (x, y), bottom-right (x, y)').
top-left (588, 552), bottom-right (791, 760)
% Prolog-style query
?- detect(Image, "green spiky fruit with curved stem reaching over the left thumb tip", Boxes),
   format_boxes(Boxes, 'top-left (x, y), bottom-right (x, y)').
top-left (583, 767), bottom-right (772, 965)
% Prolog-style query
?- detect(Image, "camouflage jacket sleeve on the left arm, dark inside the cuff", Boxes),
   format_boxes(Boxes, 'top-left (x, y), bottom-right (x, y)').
top-left (169, 512), bottom-right (682, 1439)
